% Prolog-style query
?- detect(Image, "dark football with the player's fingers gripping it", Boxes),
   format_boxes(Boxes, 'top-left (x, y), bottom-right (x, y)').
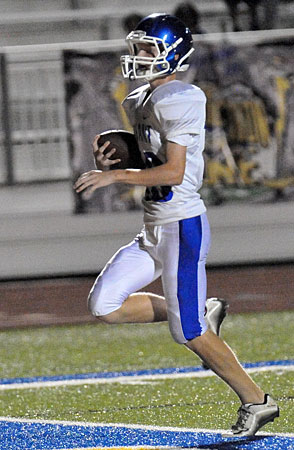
top-left (93, 130), bottom-right (145, 170)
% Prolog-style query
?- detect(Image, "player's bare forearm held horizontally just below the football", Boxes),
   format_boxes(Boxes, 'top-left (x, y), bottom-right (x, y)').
top-left (113, 164), bottom-right (183, 187)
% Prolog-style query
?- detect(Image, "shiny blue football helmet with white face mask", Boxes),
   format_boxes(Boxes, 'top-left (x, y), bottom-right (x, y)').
top-left (121, 14), bottom-right (194, 81)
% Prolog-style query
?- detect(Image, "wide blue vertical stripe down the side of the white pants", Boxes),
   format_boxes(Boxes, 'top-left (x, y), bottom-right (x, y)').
top-left (178, 216), bottom-right (206, 340)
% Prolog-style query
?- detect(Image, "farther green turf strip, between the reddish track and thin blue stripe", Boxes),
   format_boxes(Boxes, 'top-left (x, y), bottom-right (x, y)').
top-left (0, 311), bottom-right (294, 378)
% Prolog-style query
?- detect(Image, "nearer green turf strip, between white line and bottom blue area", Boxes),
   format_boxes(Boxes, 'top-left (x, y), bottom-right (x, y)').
top-left (0, 372), bottom-right (294, 432)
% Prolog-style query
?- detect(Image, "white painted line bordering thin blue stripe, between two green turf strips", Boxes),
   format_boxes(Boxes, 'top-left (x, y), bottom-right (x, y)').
top-left (0, 365), bottom-right (294, 391)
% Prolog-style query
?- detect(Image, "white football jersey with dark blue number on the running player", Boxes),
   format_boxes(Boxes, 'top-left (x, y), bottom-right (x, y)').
top-left (123, 80), bottom-right (206, 225)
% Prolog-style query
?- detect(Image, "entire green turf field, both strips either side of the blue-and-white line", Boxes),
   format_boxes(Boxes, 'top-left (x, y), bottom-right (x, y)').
top-left (0, 312), bottom-right (294, 432)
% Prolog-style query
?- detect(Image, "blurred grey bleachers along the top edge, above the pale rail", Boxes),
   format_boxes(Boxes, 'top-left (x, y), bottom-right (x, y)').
top-left (0, 0), bottom-right (294, 46)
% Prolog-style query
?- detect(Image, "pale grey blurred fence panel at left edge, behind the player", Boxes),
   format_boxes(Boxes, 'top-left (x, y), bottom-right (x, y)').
top-left (0, 50), bottom-right (70, 184)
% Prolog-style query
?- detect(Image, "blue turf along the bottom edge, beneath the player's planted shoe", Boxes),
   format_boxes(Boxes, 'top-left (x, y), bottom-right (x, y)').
top-left (0, 420), bottom-right (294, 450)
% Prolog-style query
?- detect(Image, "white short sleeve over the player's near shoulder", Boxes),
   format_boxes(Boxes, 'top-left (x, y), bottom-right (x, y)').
top-left (154, 90), bottom-right (206, 141)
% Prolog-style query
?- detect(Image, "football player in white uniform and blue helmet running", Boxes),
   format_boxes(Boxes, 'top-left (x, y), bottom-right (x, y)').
top-left (75, 14), bottom-right (279, 437)
